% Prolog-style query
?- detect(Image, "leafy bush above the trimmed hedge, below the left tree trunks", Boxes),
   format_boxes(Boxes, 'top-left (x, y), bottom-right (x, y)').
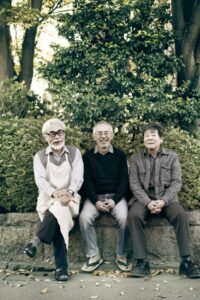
top-left (0, 78), bottom-right (47, 118)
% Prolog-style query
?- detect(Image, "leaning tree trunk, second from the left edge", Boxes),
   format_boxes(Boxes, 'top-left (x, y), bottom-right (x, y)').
top-left (19, 0), bottom-right (42, 88)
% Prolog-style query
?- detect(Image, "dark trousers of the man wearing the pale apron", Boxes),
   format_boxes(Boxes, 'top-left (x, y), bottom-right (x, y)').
top-left (37, 211), bottom-right (68, 269)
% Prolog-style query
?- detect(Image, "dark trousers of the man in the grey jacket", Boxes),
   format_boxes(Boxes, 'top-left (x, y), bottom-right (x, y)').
top-left (128, 201), bottom-right (190, 259)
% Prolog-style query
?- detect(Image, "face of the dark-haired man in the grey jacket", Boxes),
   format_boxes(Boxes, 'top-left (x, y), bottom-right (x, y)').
top-left (144, 129), bottom-right (163, 154)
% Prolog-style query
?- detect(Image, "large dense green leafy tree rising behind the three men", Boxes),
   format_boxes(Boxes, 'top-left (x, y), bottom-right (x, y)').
top-left (43, 0), bottom-right (200, 130)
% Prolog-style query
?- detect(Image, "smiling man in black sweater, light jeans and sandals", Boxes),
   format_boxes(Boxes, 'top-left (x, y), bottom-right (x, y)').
top-left (79, 121), bottom-right (128, 272)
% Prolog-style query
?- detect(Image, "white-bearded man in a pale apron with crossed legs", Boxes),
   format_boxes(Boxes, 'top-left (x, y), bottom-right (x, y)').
top-left (24, 119), bottom-right (83, 281)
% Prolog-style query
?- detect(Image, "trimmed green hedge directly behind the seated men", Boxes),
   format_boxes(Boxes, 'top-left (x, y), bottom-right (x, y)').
top-left (0, 119), bottom-right (200, 212)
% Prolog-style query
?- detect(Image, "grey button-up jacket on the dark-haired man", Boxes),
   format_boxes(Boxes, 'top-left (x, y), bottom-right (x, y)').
top-left (129, 148), bottom-right (181, 206)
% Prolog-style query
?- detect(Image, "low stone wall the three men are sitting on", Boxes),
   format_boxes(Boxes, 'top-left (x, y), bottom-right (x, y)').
top-left (0, 210), bottom-right (200, 263)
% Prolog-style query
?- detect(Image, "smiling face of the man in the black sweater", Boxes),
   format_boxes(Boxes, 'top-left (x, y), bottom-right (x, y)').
top-left (93, 124), bottom-right (114, 154)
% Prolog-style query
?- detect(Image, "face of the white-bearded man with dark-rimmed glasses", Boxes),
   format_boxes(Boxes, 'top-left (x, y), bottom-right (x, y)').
top-left (44, 123), bottom-right (65, 154)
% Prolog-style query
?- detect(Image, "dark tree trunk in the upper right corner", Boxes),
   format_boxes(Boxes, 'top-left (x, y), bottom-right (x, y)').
top-left (172, 0), bottom-right (200, 92)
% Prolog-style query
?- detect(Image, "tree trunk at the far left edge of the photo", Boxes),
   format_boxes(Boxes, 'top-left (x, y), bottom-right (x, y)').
top-left (0, 0), bottom-right (14, 81)
